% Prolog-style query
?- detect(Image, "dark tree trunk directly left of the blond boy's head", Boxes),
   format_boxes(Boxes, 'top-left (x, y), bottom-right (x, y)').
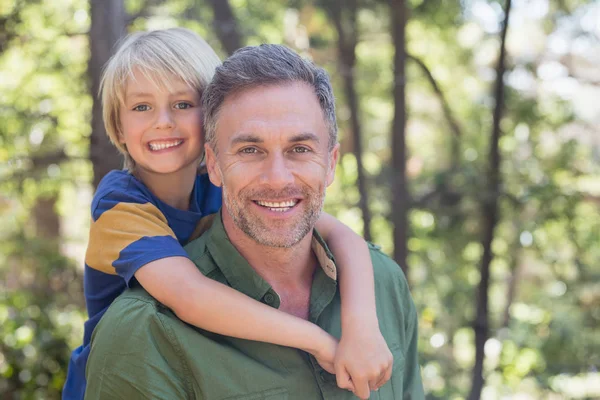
top-left (88, 0), bottom-right (127, 188)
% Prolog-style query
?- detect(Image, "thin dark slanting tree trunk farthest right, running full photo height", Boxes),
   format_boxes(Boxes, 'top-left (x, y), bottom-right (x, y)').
top-left (469, 0), bottom-right (511, 400)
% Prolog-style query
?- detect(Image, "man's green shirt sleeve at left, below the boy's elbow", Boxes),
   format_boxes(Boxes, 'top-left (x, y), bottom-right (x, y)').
top-left (85, 296), bottom-right (193, 400)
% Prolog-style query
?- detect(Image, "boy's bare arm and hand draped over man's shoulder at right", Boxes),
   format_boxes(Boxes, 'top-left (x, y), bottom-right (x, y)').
top-left (316, 213), bottom-right (393, 399)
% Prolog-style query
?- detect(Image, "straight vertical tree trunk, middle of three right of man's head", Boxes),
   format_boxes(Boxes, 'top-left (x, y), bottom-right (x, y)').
top-left (389, 0), bottom-right (410, 277)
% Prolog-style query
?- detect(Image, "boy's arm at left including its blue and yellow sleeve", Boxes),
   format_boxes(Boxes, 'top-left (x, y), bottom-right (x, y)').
top-left (86, 190), bottom-right (337, 372)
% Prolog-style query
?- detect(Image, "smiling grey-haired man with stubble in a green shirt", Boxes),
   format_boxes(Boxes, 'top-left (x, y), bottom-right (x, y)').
top-left (86, 45), bottom-right (424, 400)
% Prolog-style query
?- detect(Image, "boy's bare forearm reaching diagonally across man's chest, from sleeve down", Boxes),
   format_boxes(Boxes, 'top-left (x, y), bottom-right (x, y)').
top-left (135, 257), bottom-right (337, 373)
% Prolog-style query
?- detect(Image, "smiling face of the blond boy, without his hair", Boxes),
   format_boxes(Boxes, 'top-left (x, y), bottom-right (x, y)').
top-left (119, 70), bottom-right (203, 175)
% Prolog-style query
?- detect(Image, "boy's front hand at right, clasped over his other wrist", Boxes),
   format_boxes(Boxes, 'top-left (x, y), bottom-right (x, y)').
top-left (334, 323), bottom-right (394, 399)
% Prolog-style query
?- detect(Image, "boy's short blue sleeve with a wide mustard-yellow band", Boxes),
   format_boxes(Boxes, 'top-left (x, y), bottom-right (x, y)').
top-left (85, 190), bottom-right (187, 285)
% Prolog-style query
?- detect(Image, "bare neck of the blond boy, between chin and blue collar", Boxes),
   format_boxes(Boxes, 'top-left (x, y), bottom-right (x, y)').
top-left (133, 165), bottom-right (197, 210)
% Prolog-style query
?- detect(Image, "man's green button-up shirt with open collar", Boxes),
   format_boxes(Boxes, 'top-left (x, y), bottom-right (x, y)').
top-left (85, 217), bottom-right (425, 400)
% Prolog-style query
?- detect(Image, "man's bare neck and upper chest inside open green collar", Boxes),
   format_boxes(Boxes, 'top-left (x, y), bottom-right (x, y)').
top-left (222, 207), bottom-right (318, 318)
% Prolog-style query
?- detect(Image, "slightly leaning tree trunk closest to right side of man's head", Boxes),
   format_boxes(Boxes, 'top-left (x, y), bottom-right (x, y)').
top-left (327, 0), bottom-right (371, 241)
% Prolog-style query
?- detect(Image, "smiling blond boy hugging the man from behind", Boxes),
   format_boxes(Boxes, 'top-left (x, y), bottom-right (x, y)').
top-left (63, 29), bottom-right (393, 399)
